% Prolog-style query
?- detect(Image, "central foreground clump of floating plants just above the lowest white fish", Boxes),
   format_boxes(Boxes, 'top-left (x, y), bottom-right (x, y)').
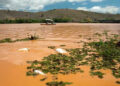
top-left (28, 54), bottom-right (84, 75)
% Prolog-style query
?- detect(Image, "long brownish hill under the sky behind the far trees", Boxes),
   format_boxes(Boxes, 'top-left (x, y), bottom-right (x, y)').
top-left (0, 9), bottom-right (120, 22)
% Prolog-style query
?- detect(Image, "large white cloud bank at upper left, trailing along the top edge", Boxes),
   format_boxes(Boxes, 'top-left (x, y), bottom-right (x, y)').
top-left (0, 0), bottom-right (106, 11)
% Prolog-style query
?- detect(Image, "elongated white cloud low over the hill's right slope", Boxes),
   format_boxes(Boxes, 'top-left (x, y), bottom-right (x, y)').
top-left (77, 6), bottom-right (120, 14)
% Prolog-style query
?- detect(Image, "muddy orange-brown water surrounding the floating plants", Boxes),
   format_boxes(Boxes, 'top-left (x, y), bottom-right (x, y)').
top-left (0, 23), bottom-right (120, 86)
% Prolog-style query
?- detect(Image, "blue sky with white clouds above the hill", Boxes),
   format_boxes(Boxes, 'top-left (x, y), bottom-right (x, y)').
top-left (0, 0), bottom-right (120, 14)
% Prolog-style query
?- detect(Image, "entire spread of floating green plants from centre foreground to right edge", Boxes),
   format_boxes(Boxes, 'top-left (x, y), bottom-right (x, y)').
top-left (27, 32), bottom-right (120, 86)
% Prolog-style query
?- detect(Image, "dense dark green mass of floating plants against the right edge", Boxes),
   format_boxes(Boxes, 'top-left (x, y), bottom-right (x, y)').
top-left (83, 32), bottom-right (120, 78)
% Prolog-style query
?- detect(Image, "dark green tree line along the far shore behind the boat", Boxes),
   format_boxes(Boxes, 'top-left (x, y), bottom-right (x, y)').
top-left (0, 18), bottom-right (120, 24)
